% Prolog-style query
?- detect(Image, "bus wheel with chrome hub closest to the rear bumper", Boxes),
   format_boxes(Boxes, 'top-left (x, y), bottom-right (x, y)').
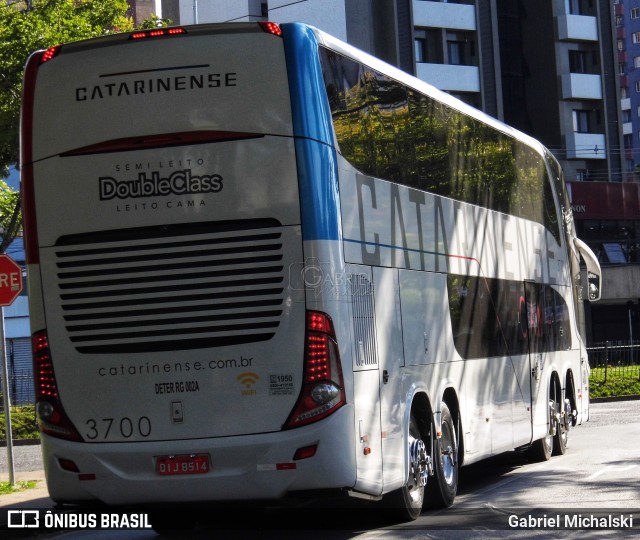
top-left (388, 413), bottom-right (429, 521)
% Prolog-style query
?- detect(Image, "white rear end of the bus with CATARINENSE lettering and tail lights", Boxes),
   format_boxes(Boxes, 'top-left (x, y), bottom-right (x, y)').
top-left (22, 24), bottom-right (355, 505)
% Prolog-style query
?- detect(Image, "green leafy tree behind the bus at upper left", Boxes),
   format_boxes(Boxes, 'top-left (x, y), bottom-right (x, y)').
top-left (0, 0), bottom-right (166, 252)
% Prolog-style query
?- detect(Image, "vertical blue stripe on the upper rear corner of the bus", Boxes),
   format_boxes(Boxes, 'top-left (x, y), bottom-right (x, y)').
top-left (282, 23), bottom-right (340, 240)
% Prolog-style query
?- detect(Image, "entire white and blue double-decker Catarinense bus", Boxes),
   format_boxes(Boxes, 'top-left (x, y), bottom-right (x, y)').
top-left (21, 23), bottom-right (600, 524)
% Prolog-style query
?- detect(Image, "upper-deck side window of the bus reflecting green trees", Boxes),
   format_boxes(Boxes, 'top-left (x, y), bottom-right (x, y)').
top-left (322, 49), bottom-right (560, 242)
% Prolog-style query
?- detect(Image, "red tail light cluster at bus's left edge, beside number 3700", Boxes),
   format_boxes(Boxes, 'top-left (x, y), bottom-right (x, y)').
top-left (31, 330), bottom-right (82, 441)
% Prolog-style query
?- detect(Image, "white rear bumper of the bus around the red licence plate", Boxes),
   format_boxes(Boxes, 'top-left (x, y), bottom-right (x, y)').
top-left (42, 405), bottom-right (356, 505)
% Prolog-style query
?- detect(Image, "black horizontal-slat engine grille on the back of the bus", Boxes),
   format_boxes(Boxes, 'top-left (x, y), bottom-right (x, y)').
top-left (56, 220), bottom-right (284, 354)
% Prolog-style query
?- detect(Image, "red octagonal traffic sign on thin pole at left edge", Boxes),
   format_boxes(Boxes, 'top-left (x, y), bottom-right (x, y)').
top-left (0, 255), bottom-right (23, 486)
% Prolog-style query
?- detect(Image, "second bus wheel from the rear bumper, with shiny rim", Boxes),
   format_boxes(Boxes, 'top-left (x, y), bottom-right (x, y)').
top-left (427, 402), bottom-right (458, 508)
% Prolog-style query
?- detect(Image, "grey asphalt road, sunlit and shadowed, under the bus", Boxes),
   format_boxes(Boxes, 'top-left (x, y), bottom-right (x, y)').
top-left (0, 401), bottom-right (640, 540)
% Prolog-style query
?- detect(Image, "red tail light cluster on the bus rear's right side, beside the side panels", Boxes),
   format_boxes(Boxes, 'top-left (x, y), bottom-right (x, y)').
top-left (284, 311), bottom-right (347, 429)
